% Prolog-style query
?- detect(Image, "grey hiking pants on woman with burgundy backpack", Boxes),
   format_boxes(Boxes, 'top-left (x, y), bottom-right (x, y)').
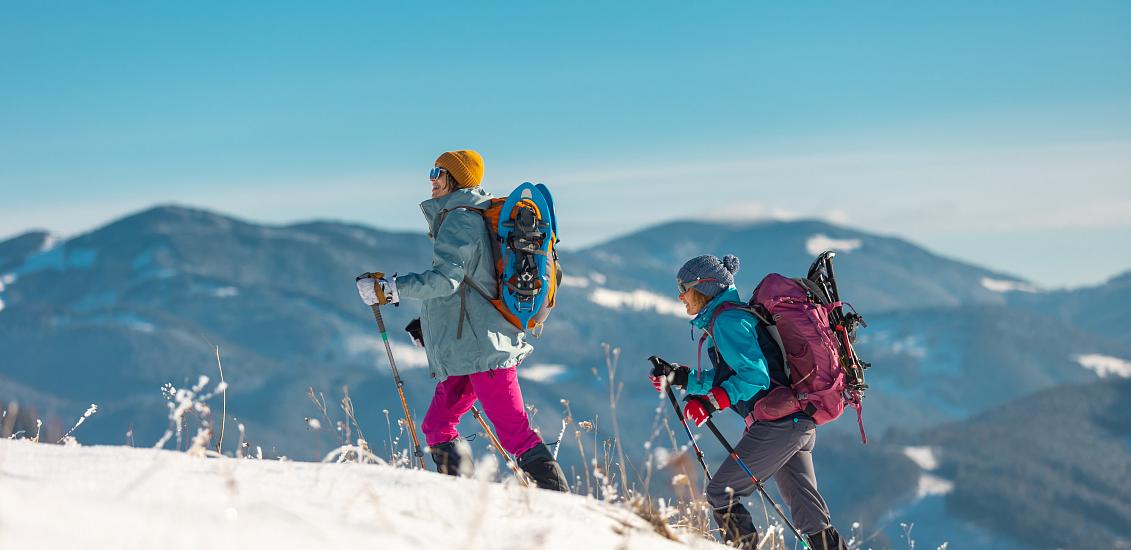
top-left (707, 416), bottom-right (830, 541)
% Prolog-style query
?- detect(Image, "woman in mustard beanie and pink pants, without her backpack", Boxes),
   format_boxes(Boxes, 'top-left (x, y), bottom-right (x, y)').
top-left (357, 151), bottom-right (569, 491)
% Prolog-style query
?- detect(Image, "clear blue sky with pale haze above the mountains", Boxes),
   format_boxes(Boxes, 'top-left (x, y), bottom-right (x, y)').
top-left (0, 0), bottom-right (1131, 286)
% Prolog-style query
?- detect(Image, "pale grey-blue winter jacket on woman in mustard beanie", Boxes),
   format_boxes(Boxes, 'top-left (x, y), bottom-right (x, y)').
top-left (396, 188), bottom-right (534, 380)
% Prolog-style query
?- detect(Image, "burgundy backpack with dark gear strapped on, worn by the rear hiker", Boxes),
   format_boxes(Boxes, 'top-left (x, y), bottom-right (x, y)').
top-left (710, 251), bottom-right (869, 444)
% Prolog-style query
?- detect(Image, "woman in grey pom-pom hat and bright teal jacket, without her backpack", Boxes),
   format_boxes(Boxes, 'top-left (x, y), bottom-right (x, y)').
top-left (651, 256), bottom-right (846, 550)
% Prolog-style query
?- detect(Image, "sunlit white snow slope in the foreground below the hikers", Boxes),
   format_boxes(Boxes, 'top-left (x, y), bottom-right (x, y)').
top-left (0, 440), bottom-right (723, 550)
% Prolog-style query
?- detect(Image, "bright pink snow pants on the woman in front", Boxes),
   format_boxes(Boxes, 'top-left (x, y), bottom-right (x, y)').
top-left (421, 367), bottom-right (542, 457)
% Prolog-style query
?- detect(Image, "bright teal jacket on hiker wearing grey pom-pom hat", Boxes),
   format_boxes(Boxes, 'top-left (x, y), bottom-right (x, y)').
top-left (687, 286), bottom-right (770, 404)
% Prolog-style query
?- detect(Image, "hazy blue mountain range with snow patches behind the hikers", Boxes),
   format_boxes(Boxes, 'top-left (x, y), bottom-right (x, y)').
top-left (0, 206), bottom-right (1131, 548)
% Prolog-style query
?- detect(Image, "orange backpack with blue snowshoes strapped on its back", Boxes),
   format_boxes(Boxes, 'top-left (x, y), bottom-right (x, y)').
top-left (437, 182), bottom-right (562, 330)
